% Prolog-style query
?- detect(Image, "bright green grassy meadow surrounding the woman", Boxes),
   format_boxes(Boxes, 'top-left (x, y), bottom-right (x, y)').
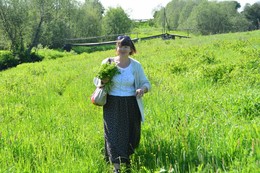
top-left (0, 31), bottom-right (260, 173)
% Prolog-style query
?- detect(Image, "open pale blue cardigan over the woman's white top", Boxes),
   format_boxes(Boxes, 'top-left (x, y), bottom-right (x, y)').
top-left (102, 58), bottom-right (151, 122)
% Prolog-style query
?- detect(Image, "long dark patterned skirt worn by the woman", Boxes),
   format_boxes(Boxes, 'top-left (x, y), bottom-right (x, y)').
top-left (103, 95), bottom-right (141, 163)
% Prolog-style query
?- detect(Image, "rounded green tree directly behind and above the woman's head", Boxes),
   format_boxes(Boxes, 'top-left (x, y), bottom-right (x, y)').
top-left (103, 7), bottom-right (132, 38)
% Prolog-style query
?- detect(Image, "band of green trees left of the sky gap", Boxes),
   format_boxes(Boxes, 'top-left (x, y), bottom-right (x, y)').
top-left (0, 0), bottom-right (132, 62)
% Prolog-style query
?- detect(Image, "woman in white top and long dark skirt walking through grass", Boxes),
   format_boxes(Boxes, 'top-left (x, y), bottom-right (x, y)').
top-left (102, 36), bottom-right (150, 173)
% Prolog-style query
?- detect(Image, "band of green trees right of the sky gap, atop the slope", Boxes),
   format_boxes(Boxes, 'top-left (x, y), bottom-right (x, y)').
top-left (154, 0), bottom-right (260, 35)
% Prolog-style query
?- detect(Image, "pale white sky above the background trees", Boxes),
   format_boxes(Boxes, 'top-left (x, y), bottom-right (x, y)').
top-left (97, 0), bottom-right (260, 19)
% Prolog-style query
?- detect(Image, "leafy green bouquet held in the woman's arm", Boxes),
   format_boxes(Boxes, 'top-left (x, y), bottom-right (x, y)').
top-left (97, 62), bottom-right (120, 92)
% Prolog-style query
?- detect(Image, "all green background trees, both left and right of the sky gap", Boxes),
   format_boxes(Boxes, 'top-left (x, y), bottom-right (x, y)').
top-left (0, 0), bottom-right (260, 59)
